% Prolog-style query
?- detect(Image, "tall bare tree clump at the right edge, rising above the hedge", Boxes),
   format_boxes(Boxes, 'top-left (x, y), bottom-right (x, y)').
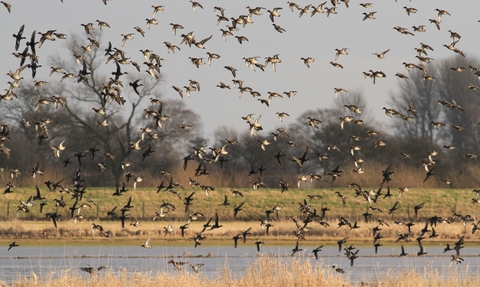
top-left (390, 56), bottom-right (480, 162)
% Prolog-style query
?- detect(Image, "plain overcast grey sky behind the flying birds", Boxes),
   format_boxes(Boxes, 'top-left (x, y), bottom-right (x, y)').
top-left (0, 0), bottom-right (480, 138)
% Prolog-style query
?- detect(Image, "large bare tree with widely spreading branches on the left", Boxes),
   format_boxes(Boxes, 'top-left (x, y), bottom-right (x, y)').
top-left (2, 32), bottom-right (202, 185)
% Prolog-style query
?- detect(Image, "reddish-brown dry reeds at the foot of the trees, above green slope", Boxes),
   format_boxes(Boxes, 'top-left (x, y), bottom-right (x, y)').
top-left (8, 158), bottom-right (480, 190)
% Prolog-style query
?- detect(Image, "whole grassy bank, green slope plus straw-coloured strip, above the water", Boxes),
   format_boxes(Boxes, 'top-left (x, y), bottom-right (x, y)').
top-left (0, 187), bottom-right (480, 248)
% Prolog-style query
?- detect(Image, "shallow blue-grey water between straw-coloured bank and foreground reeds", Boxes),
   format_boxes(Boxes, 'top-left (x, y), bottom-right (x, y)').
top-left (0, 243), bottom-right (480, 283)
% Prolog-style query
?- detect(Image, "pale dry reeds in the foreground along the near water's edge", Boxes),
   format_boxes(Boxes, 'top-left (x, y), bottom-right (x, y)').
top-left (5, 258), bottom-right (480, 287)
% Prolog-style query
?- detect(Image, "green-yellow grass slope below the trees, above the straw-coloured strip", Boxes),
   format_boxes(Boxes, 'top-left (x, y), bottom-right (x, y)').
top-left (0, 187), bottom-right (479, 222)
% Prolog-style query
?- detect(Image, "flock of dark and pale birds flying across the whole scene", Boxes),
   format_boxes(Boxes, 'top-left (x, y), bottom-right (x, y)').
top-left (0, 0), bottom-right (480, 273)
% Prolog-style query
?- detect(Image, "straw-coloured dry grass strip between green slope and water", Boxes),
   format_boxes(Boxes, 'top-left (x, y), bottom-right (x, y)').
top-left (0, 219), bottom-right (480, 246)
